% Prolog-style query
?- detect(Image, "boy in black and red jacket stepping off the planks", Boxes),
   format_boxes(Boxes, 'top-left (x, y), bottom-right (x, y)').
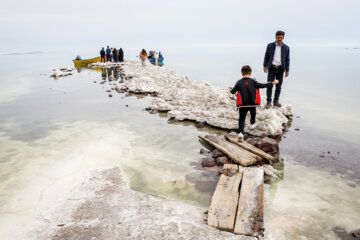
top-left (230, 65), bottom-right (279, 142)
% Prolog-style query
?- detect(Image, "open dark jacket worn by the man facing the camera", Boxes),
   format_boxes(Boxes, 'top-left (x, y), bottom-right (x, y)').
top-left (264, 42), bottom-right (290, 72)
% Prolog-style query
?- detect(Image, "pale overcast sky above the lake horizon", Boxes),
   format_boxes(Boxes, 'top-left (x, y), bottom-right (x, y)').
top-left (0, 0), bottom-right (360, 53)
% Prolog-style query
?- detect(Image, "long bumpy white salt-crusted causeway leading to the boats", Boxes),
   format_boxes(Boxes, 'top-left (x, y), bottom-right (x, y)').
top-left (91, 61), bottom-right (293, 136)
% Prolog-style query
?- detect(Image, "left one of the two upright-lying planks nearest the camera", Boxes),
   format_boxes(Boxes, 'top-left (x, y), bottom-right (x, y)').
top-left (208, 172), bottom-right (242, 231)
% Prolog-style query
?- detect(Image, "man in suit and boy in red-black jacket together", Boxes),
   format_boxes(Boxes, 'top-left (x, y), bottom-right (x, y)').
top-left (230, 30), bottom-right (290, 142)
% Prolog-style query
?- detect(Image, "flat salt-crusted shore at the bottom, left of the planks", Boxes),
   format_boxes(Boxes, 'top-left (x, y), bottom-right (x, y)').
top-left (28, 168), bottom-right (257, 240)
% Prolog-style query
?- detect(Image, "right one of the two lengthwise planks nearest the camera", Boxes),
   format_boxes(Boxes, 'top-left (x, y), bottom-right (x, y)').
top-left (234, 168), bottom-right (264, 236)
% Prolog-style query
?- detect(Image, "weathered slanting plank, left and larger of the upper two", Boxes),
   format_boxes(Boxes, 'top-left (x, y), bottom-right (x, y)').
top-left (199, 135), bottom-right (262, 167)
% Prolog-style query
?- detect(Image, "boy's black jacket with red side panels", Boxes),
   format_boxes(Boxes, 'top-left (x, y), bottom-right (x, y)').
top-left (230, 77), bottom-right (272, 107)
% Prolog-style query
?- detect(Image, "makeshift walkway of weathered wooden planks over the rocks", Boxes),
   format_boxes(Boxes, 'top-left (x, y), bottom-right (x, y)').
top-left (199, 135), bottom-right (275, 236)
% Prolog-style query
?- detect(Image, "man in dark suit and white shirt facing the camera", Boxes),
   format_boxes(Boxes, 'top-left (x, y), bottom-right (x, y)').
top-left (264, 30), bottom-right (290, 108)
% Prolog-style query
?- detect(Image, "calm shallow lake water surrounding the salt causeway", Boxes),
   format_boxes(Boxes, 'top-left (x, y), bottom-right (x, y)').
top-left (0, 47), bottom-right (360, 239)
